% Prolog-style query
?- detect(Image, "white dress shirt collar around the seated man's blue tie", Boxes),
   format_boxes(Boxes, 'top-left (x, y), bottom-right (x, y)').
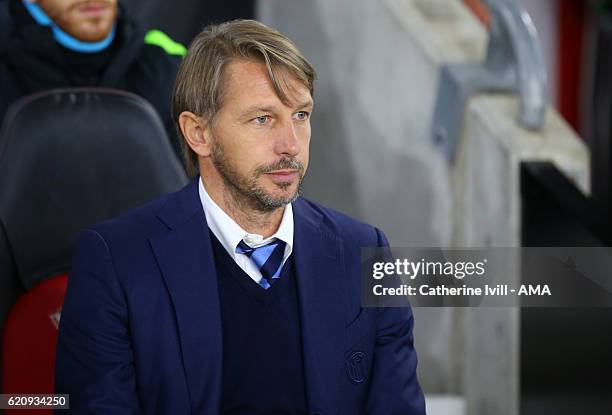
top-left (199, 177), bottom-right (293, 284)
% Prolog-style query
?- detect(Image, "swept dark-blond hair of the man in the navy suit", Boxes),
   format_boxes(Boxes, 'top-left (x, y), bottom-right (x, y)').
top-left (172, 20), bottom-right (316, 177)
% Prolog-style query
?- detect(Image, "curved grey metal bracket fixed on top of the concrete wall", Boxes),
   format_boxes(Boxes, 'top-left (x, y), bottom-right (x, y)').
top-left (432, 0), bottom-right (548, 161)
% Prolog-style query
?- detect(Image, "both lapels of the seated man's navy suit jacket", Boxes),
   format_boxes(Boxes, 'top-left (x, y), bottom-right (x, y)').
top-left (150, 180), bottom-right (345, 414)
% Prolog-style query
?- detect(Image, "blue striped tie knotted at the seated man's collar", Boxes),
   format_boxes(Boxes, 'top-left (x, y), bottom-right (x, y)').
top-left (236, 239), bottom-right (285, 290)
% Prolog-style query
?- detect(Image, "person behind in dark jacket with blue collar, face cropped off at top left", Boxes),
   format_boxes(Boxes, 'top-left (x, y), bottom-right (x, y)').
top-left (0, 0), bottom-right (186, 158)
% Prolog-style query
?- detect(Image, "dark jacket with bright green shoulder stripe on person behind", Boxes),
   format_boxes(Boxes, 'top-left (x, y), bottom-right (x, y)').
top-left (0, 0), bottom-right (185, 158)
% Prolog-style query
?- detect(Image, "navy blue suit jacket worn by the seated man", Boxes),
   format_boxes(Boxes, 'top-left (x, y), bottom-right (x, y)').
top-left (56, 180), bottom-right (425, 415)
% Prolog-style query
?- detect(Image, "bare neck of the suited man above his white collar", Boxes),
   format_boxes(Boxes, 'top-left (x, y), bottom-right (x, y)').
top-left (202, 181), bottom-right (285, 238)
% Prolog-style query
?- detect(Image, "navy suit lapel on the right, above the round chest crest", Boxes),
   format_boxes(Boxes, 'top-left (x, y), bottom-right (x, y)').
top-left (294, 199), bottom-right (345, 414)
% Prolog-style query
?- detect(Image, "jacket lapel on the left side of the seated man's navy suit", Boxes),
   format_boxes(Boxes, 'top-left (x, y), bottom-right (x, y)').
top-left (150, 181), bottom-right (223, 414)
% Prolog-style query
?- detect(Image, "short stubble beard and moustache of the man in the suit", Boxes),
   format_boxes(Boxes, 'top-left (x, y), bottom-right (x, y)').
top-left (211, 140), bottom-right (304, 213)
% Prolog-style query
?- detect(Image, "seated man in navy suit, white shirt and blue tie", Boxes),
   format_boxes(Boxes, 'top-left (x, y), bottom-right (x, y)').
top-left (56, 21), bottom-right (425, 415)
